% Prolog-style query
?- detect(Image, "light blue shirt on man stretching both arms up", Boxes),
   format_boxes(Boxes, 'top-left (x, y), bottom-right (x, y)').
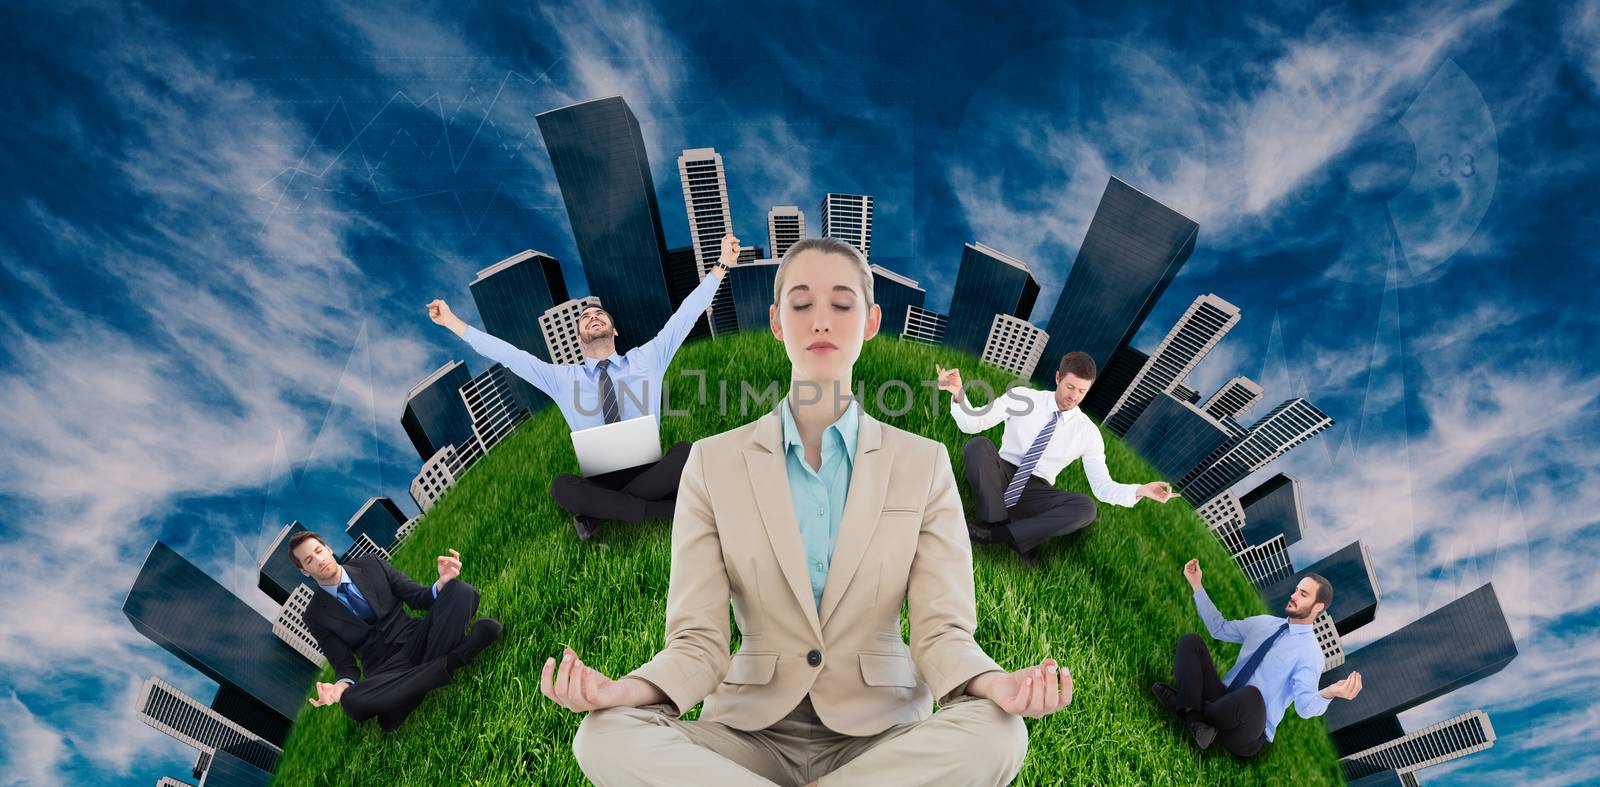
top-left (462, 274), bottom-right (722, 432)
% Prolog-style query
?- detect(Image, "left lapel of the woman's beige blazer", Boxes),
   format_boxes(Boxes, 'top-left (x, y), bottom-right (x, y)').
top-left (744, 401), bottom-right (822, 641)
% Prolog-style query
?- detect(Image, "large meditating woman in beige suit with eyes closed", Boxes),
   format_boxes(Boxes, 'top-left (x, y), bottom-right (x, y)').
top-left (541, 238), bottom-right (1072, 785)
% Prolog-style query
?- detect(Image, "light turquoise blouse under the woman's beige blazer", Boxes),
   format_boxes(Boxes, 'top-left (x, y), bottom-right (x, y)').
top-left (781, 397), bottom-right (859, 609)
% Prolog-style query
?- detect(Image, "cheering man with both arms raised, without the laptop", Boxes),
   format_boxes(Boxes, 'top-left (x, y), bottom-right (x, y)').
top-left (427, 232), bottom-right (739, 541)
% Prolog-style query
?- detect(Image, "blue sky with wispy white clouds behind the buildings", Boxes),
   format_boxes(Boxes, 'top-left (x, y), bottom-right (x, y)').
top-left (0, 0), bottom-right (1600, 784)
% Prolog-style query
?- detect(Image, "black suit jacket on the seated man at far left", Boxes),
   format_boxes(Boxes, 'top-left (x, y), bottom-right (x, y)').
top-left (306, 555), bottom-right (434, 681)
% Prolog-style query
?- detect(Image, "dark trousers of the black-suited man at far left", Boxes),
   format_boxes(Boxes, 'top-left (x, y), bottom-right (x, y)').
top-left (339, 579), bottom-right (478, 729)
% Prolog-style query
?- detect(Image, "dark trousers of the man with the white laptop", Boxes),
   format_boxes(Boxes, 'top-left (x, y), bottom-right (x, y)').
top-left (550, 440), bottom-right (693, 521)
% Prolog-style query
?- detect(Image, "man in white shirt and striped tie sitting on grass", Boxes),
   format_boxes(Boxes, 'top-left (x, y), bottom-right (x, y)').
top-left (934, 352), bottom-right (1179, 565)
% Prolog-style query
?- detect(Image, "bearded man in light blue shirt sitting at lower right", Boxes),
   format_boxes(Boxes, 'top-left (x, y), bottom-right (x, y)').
top-left (1150, 560), bottom-right (1362, 757)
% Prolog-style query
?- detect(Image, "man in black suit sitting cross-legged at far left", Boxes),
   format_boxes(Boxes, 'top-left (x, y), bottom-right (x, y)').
top-left (288, 531), bottom-right (501, 733)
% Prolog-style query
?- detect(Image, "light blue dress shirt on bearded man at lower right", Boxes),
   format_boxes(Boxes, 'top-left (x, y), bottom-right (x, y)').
top-left (1195, 589), bottom-right (1331, 741)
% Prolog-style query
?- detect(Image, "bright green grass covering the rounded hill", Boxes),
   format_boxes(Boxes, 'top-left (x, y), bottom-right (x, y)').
top-left (275, 333), bottom-right (1341, 785)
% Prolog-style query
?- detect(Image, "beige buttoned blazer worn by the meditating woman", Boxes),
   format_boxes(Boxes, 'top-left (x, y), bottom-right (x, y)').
top-left (630, 401), bottom-right (1000, 736)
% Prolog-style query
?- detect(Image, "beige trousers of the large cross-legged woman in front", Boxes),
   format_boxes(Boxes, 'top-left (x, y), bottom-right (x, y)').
top-left (573, 697), bottom-right (1027, 787)
